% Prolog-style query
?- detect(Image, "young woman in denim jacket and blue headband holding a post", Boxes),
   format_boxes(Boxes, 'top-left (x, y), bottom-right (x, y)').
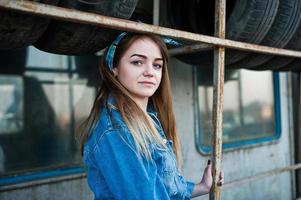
top-left (81, 32), bottom-right (223, 200)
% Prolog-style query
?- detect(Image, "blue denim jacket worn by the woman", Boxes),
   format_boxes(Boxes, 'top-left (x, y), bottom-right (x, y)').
top-left (83, 99), bottom-right (194, 200)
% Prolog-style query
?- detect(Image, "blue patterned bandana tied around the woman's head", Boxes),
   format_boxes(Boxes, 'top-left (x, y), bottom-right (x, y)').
top-left (106, 32), bottom-right (182, 71)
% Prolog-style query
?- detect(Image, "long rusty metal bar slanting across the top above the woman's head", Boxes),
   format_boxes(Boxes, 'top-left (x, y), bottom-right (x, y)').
top-left (0, 0), bottom-right (301, 58)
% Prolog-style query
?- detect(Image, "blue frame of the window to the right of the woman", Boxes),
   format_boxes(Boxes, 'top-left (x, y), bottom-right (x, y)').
top-left (193, 66), bottom-right (282, 155)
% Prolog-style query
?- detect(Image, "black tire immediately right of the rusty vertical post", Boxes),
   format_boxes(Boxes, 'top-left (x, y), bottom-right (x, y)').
top-left (226, 0), bottom-right (279, 65)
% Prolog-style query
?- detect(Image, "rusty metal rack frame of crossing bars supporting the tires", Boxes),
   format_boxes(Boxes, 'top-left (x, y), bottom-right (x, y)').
top-left (0, 0), bottom-right (301, 199)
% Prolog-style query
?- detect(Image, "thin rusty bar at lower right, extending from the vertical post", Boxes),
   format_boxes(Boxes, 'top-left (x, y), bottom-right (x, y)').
top-left (223, 163), bottom-right (301, 187)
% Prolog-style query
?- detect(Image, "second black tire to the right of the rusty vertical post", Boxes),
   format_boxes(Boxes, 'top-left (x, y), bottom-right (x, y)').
top-left (229, 0), bottom-right (301, 69)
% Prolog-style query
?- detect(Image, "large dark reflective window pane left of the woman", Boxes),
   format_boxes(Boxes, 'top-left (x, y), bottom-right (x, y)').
top-left (0, 47), bottom-right (99, 184)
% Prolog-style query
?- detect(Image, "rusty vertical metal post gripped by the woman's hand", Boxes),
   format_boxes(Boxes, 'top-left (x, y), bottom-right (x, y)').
top-left (210, 0), bottom-right (226, 200)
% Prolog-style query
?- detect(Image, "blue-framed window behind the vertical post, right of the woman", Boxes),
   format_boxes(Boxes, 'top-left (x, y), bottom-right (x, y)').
top-left (196, 68), bottom-right (280, 153)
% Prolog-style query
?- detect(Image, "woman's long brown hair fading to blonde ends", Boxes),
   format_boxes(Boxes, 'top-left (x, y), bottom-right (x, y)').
top-left (80, 33), bottom-right (182, 167)
